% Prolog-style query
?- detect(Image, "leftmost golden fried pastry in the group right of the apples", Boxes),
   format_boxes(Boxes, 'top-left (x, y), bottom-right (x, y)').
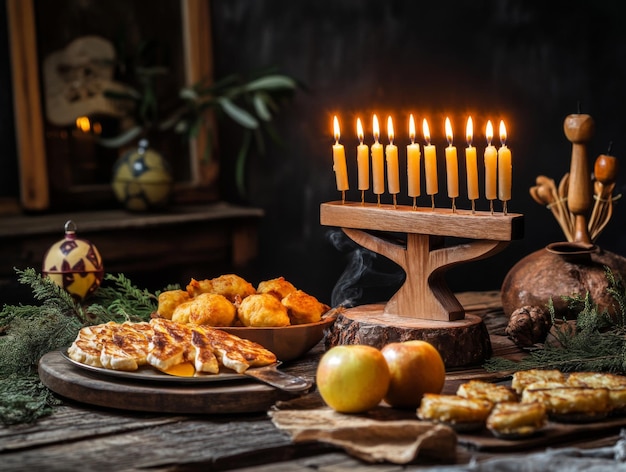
top-left (417, 393), bottom-right (493, 425)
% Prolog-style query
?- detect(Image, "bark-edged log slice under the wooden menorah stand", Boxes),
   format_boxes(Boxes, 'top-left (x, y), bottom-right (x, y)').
top-left (325, 304), bottom-right (492, 367)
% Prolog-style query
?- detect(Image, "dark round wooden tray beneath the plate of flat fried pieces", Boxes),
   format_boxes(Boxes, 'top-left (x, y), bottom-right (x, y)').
top-left (39, 351), bottom-right (304, 414)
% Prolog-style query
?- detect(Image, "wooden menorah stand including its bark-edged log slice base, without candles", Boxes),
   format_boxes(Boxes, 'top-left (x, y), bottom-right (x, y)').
top-left (320, 202), bottom-right (523, 367)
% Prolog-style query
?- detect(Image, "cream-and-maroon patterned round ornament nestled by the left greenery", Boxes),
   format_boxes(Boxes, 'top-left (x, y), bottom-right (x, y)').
top-left (42, 220), bottom-right (104, 301)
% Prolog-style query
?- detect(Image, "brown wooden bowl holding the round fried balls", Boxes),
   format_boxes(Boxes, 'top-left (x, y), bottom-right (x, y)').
top-left (219, 317), bottom-right (335, 362)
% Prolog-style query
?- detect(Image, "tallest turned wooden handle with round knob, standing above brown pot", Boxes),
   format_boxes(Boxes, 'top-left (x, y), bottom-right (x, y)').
top-left (563, 114), bottom-right (595, 243)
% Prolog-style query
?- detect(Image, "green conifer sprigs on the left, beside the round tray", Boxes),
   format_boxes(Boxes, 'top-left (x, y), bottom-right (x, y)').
top-left (0, 268), bottom-right (166, 424)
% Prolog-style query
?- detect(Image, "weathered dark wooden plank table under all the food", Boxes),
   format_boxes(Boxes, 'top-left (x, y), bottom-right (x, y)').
top-left (0, 293), bottom-right (619, 472)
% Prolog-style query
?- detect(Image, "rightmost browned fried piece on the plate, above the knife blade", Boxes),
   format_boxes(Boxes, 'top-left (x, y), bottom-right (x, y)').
top-left (192, 324), bottom-right (276, 374)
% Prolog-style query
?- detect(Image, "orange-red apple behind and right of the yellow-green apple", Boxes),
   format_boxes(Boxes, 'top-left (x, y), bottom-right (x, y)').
top-left (381, 340), bottom-right (446, 408)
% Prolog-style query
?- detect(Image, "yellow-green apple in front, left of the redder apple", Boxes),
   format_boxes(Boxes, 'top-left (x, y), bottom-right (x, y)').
top-left (316, 344), bottom-right (389, 413)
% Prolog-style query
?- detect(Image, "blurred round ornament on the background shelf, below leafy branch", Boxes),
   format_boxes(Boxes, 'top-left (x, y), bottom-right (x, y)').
top-left (112, 139), bottom-right (172, 211)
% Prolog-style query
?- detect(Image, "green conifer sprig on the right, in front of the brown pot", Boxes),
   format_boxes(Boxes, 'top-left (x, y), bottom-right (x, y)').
top-left (484, 267), bottom-right (626, 373)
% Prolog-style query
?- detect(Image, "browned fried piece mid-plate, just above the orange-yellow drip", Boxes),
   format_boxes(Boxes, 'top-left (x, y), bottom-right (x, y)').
top-left (147, 318), bottom-right (195, 370)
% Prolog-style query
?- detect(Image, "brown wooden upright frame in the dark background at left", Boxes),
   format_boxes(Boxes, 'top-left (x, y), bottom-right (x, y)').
top-left (6, 0), bottom-right (218, 211)
